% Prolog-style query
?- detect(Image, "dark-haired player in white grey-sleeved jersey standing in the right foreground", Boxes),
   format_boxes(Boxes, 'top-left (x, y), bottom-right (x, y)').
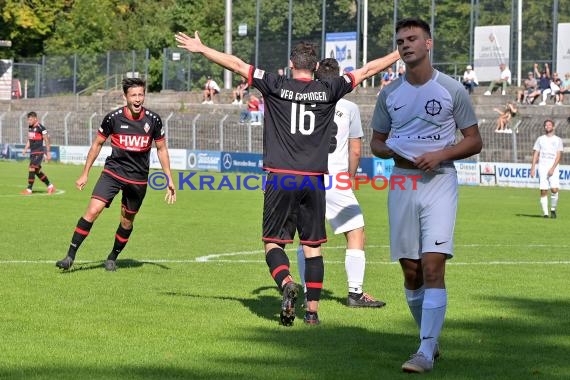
top-left (370, 18), bottom-right (483, 372)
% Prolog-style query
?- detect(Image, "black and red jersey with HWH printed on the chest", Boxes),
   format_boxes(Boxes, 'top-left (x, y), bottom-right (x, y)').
top-left (98, 107), bottom-right (165, 183)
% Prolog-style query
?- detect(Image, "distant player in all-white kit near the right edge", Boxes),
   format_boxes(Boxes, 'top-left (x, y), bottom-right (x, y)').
top-left (530, 119), bottom-right (564, 219)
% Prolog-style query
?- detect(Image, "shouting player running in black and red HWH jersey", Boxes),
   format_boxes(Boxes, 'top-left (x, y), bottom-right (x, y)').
top-left (55, 78), bottom-right (176, 271)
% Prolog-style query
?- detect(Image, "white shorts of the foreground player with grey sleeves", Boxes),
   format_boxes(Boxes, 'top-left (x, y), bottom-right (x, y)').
top-left (388, 167), bottom-right (457, 261)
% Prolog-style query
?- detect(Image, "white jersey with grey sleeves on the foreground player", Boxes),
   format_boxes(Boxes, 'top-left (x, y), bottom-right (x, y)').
top-left (372, 70), bottom-right (477, 161)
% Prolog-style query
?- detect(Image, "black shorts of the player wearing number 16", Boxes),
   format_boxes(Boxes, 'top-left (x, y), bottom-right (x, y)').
top-left (263, 173), bottom-right (327, 245)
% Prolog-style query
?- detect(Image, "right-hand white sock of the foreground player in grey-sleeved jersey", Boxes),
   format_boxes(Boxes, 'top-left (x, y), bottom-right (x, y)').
top-left (418, 288), bottom-right (447, 360)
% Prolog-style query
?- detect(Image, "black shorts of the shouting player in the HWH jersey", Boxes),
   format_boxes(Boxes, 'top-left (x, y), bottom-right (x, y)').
top-left (91, 172), bottom-right (147, 214)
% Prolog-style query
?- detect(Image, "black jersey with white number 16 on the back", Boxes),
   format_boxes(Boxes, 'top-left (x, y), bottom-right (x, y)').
top-left (248, 67), bottom-right (354, 174)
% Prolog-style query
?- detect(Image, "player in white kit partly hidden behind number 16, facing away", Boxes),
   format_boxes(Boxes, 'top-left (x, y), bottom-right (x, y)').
top-left (297, 58), bottom-right (386, 308)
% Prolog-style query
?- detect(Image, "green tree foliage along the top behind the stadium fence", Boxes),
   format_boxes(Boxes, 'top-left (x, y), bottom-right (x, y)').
top-left (0, 0), bottom-right (570, 88)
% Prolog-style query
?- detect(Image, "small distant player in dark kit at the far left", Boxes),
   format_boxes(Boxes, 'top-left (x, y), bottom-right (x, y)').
top-left (20, 111), bottom-right (55, 195)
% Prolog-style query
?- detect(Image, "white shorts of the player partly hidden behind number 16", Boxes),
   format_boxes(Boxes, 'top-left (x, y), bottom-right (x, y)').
top-left (325, 176), bottom-right (364, 234)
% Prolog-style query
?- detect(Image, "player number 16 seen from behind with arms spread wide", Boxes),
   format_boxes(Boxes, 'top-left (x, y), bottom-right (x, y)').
top-left (175, 32), bottom-right (399, 326)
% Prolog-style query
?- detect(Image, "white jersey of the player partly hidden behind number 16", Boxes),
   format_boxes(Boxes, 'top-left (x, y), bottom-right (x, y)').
top-left (328, 99), bottom-right (364, 174)
